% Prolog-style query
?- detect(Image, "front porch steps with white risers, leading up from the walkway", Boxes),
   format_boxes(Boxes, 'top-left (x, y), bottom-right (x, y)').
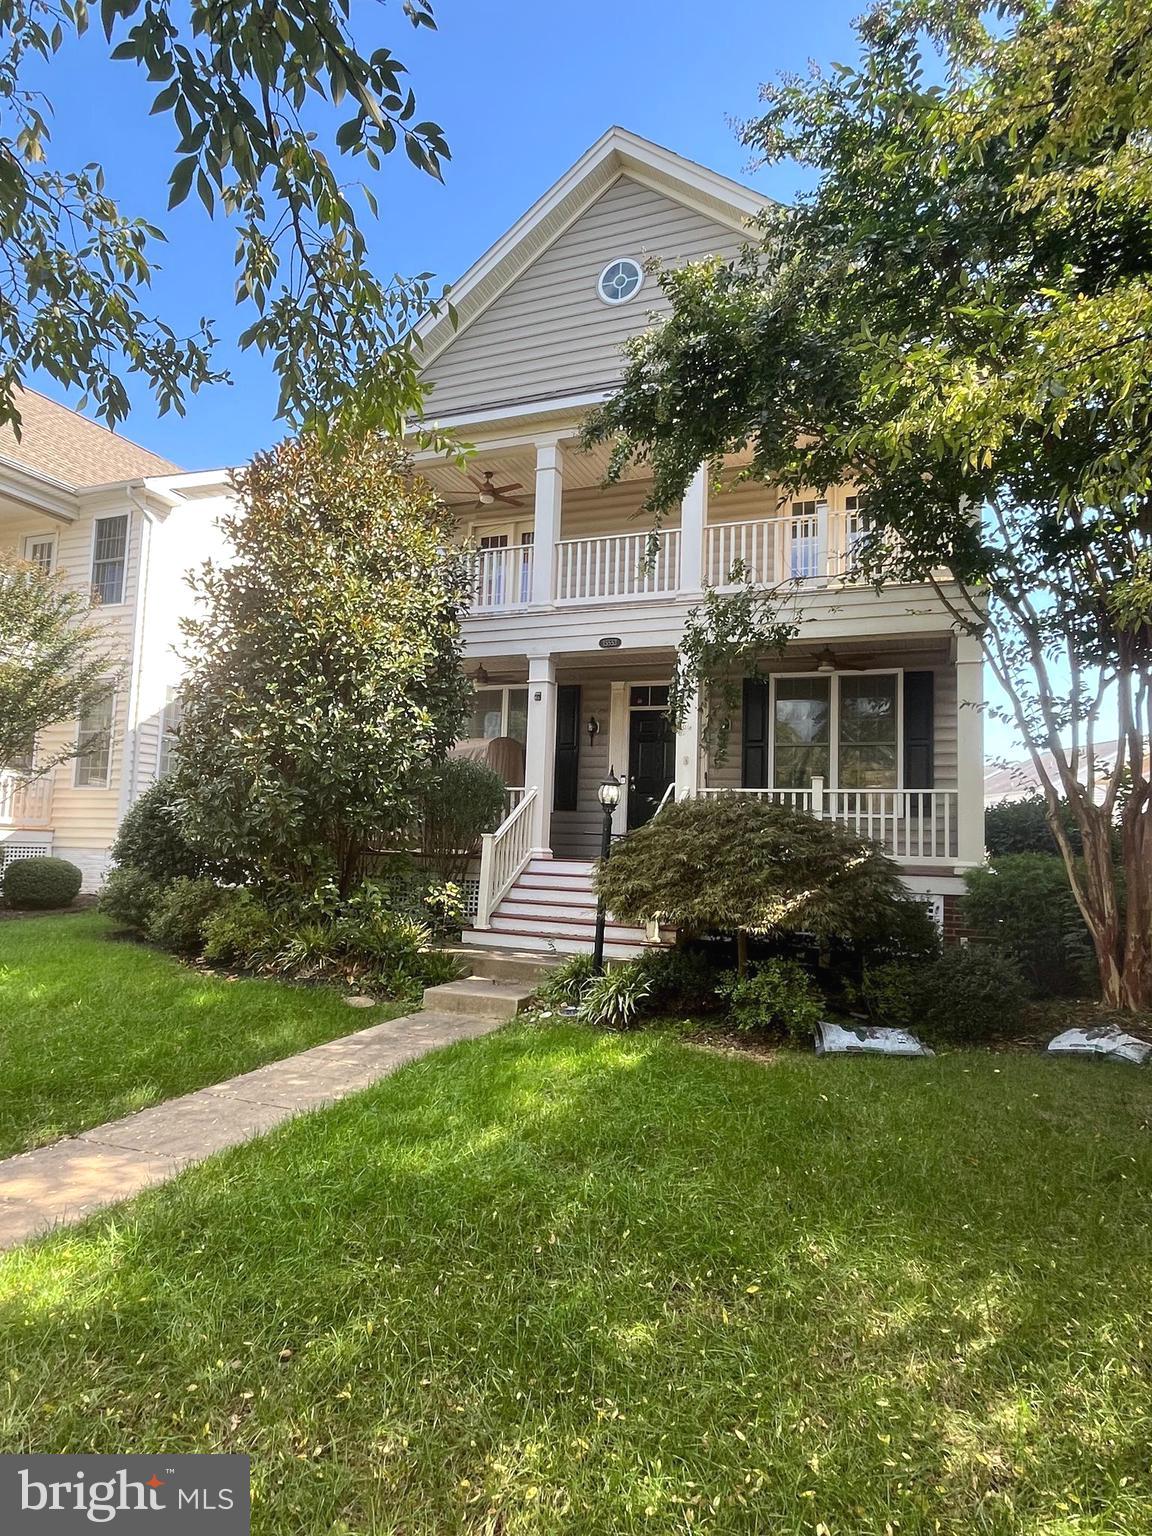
top-left (464, 859), bottom-right (673, 960)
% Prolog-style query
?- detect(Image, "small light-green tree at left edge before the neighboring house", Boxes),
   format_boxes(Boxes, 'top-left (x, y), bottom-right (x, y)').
top-left (0, 550), bottom-right (115, 774)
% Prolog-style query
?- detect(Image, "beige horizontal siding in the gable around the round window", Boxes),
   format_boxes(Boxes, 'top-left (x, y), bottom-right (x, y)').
top-left (424, 177), bottom-right (740, 418)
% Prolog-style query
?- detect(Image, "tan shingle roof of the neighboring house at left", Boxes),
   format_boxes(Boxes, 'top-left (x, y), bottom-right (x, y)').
top-left (0, 389), bottom-right (180, 490)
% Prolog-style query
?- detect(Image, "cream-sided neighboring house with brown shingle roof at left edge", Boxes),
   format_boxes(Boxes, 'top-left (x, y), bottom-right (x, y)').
top-left (0, 390), bottom-right (229, 889)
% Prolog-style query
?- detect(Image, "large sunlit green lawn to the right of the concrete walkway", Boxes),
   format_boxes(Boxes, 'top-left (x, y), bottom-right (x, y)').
top-left (0, 1023), bottom-right (1152, 1536)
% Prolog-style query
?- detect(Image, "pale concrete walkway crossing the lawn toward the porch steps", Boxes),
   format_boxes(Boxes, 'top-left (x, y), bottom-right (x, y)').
top-left (0, 1012), bottom-right (502, 1249)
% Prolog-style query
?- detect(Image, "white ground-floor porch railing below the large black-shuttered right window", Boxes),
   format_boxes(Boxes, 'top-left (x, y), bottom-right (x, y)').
top-left (699, 779), bottom-right (958, 863)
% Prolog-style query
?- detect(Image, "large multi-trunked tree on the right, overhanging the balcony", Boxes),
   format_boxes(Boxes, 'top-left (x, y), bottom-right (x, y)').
top-left (588, 0), bottom-right (1152, 1009)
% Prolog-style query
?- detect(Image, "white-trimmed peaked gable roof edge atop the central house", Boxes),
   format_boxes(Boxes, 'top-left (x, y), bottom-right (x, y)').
top-left (416, 127), bottom-right (773, 367)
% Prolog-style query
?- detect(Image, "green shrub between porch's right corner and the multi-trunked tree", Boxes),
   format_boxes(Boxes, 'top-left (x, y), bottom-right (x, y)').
top-left (960, 854), bottom-right (1097, 997)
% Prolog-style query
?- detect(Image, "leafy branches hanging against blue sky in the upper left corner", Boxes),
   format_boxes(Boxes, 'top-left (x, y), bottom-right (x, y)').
top-left (0, 0), bottom-right (449, 436)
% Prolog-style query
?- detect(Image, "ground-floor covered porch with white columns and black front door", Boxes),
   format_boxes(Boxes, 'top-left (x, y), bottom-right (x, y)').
top-left (457, 636), bottom-right (983, 927)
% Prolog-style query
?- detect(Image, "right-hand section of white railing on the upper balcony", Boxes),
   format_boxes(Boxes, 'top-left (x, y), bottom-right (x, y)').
top-left (703, 504), bottom-right (868, 587)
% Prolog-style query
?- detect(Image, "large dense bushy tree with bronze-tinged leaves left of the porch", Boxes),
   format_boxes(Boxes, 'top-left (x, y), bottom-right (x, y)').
top-left (174, 438), bottom-right (470, 894)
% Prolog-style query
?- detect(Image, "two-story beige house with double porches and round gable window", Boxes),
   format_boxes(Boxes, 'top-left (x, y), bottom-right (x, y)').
top-left (419, 127), bottom-right (983, 954)
